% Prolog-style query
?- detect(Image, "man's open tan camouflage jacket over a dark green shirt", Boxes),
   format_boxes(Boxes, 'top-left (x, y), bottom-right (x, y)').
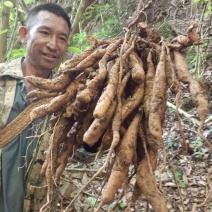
top-left (0, 58), bottom-right (56, 212)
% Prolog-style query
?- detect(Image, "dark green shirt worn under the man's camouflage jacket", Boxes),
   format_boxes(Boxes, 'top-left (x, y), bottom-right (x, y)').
top-left (0, 79), bottom-right (41, 212)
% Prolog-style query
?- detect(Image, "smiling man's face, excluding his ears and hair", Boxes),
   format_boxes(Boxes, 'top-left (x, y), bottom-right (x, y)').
top-left (26, 11), bottom-right (69, 72)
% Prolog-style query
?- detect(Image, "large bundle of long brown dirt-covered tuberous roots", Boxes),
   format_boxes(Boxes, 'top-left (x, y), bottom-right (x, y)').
top-left (0, 14), bottom-right (208, 212)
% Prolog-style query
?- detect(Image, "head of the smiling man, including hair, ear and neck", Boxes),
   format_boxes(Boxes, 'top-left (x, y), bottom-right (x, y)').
top-left (19, 3), bottom-right (71, 77)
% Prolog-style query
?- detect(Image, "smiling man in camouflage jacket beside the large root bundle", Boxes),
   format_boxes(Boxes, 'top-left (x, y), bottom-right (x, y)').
top-left (0, 3), bottom-right (71, 212)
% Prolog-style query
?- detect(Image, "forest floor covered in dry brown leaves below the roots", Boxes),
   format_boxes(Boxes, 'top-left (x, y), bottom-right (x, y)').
top-left (60, 68), bottom-right (212, 212)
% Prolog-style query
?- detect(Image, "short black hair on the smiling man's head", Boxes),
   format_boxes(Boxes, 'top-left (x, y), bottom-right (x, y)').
top-left (26, 3), bottom-right (71, 32)
